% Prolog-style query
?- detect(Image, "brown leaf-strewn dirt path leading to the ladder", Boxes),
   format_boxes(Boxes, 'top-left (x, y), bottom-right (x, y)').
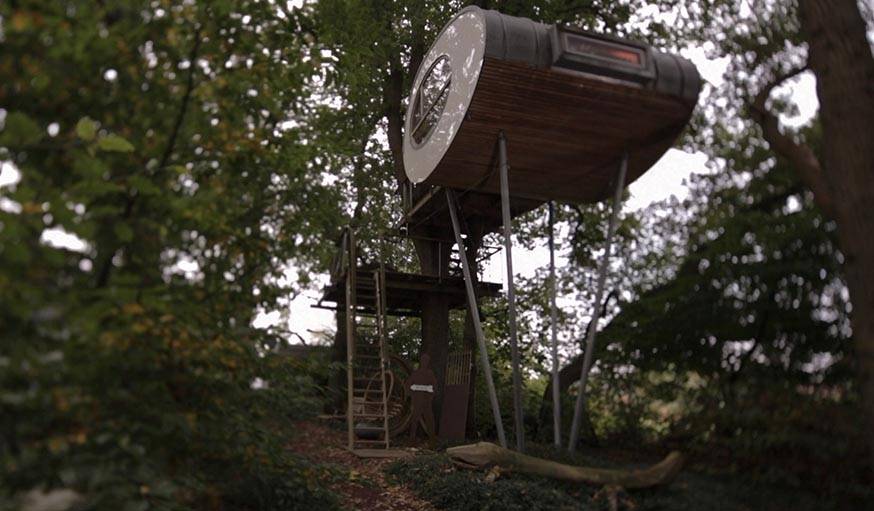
top-left (289, 421), bottom-right (434, 511)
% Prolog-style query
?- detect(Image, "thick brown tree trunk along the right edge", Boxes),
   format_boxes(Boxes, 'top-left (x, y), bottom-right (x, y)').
top-left (800, 0), bottom-right (874, 466)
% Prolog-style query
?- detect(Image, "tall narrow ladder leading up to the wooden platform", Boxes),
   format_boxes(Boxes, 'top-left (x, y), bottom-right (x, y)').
top-left (342, 227), bottom-right (390, 450)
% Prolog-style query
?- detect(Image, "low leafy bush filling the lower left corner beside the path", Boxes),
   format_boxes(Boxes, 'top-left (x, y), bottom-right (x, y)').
top-left (0, 307), bottom-right (336, 510)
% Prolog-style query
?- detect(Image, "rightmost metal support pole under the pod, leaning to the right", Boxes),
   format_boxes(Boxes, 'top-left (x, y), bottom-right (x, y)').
top-left (568, 152), bottom-right (628, 453)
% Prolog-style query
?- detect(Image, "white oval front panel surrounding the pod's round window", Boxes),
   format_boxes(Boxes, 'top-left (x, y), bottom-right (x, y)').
top-left (404, 10), bottom-right (486, 184)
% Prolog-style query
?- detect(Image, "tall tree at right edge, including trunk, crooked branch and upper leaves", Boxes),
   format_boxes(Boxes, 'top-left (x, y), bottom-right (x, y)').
top-left (688, 0), bottom-right (874, 462)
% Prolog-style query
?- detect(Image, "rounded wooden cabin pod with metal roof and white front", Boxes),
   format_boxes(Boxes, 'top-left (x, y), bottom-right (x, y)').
top-left (404, 7), bottom-right (701, 202)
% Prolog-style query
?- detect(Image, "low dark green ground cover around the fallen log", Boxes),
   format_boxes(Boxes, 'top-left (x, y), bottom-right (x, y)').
top-left (386, 444), bottom-right (871, 511)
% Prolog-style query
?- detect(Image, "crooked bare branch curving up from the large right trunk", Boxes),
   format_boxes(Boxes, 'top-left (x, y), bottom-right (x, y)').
top-left (749, 64), bottom-right (835, 218)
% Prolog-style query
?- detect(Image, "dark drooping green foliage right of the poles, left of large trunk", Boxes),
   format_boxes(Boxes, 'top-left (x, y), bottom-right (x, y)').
top-left (568, 116), bottom-right (867, 496)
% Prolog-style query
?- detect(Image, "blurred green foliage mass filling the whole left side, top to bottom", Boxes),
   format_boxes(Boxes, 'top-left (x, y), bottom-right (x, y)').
top-left (0, 1), bottom-right (337, 509)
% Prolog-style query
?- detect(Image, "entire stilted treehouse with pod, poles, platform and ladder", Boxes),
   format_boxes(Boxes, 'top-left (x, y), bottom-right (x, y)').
top-left (316, 7), bottom-right (701, 451)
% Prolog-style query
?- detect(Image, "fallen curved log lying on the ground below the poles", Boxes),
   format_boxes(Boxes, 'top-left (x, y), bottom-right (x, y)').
top-left (446, 442), bottom-right (683, 489)
